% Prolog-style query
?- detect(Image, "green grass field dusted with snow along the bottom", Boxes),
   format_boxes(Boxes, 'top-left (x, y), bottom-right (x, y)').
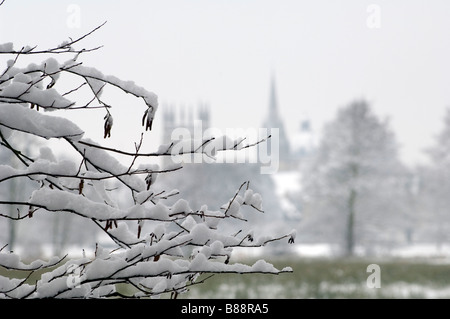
top-left (0, 257), bottom-right (450, 299)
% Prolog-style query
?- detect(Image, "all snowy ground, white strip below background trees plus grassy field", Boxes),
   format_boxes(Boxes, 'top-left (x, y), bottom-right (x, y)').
top-left (10, 244), bottom-right (450, 299)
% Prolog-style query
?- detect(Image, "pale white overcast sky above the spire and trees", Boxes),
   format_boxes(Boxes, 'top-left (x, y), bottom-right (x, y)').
top-left (0, 0), bottom-right (450, 168)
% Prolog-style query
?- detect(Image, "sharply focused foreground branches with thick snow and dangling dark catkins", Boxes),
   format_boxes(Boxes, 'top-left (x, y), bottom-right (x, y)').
top-left (0, 22), bottom-right (295, 298)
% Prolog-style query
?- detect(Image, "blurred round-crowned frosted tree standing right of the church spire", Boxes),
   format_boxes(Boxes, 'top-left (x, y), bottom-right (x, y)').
top-left (301, 100), bottom-right (402, 255)
